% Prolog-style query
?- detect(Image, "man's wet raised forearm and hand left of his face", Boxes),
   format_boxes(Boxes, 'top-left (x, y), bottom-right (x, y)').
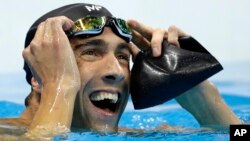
top-left (23, 17), bottom-right (80, 137)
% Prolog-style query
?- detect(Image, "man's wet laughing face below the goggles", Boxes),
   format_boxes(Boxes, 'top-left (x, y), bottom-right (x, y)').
top-left (71, 27), bottom-right (130, 131)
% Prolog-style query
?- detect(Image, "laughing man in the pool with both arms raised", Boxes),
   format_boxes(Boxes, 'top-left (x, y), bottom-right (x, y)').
top-left (0, 4), bottom-right (240, 136)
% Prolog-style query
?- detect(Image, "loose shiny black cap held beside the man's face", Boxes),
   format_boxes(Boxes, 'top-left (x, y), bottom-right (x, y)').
top-left (130, 37), bottom-right (223, 109)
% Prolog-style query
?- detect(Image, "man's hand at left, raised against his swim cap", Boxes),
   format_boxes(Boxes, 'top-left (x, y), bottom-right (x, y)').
top-left (23, 16), bottom-right (80, 92)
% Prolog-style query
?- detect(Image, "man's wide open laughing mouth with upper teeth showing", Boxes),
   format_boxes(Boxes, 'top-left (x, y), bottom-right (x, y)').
top-left (90, 92), bottom-right (119, 113)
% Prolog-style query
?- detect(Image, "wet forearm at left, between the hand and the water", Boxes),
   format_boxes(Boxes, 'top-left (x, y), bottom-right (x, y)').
top-left (30, 80), bottom-right (79, 130)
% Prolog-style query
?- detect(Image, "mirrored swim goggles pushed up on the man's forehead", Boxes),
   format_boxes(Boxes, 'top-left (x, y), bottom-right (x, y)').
top-left (66, 16), bottom-right (132, 42)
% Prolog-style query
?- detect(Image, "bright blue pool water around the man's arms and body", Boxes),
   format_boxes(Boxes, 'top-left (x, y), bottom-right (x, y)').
top-left (0, 94), bottom-right (250, 141)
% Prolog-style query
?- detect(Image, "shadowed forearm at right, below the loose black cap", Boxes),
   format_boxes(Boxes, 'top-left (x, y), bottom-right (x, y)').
top-left (176, 81), bottom-right (240, 127)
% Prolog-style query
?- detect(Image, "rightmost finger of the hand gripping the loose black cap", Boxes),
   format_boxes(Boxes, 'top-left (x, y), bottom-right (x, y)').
top-left (167, 26), bottom-right (189, 47)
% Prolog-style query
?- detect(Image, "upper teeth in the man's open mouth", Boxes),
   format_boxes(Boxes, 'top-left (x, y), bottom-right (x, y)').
top-left (90, 92), bottom-right (118, 103)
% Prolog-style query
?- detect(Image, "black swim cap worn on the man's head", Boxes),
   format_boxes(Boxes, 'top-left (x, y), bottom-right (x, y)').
top-left (23, 3), bottom-right (112, 84)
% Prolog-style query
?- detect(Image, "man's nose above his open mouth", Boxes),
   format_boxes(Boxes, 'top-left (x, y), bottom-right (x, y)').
top-left (102, 56), bottom-right (125, 84)
